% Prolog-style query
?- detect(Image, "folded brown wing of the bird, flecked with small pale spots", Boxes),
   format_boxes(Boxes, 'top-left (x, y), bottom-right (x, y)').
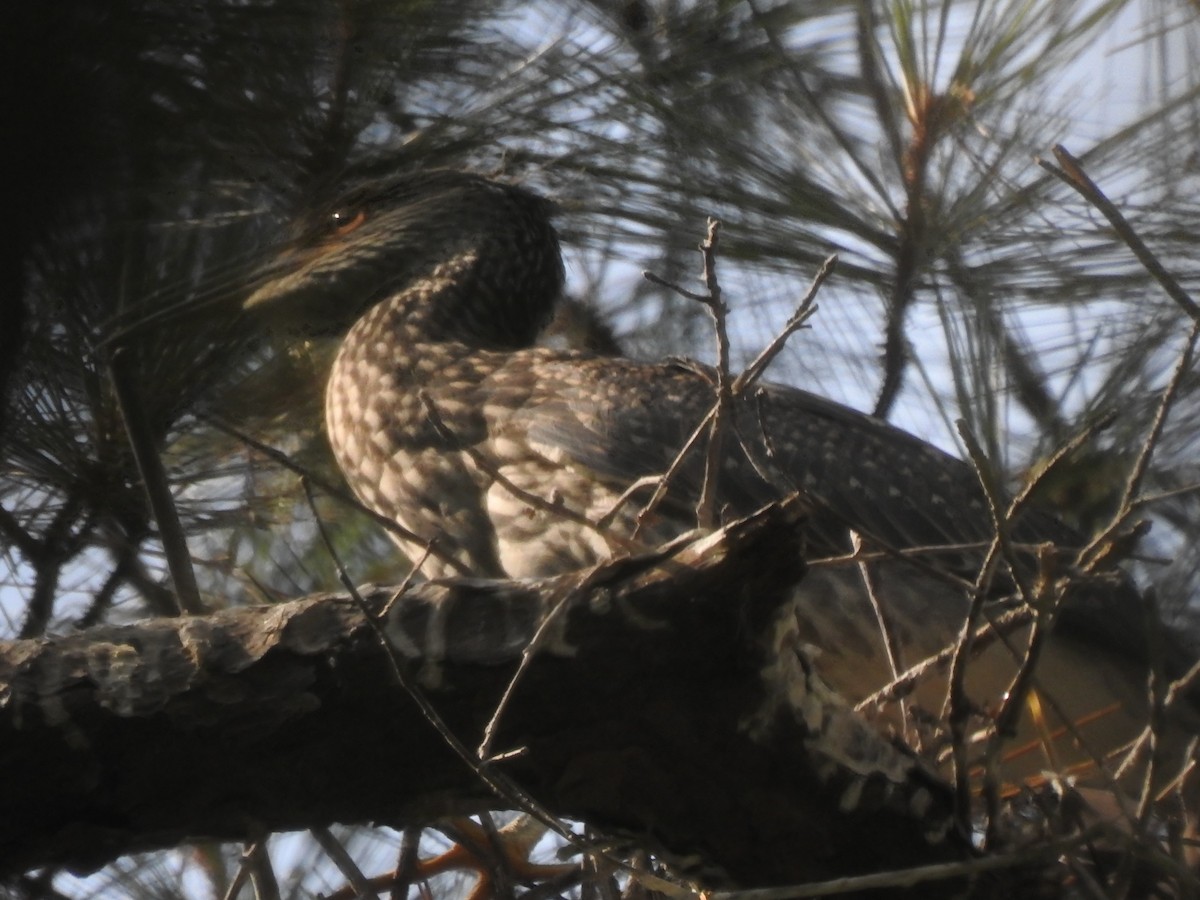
top-left (496, 358), bottom-right (1078, 561)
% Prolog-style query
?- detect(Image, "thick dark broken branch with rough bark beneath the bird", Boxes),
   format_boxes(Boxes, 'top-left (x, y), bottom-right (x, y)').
top-left (0, 508), bottom-right (967, 886)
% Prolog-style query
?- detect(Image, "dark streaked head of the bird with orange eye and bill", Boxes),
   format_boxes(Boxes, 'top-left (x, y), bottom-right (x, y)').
top-left (245, 170), bottom-right (563, 347)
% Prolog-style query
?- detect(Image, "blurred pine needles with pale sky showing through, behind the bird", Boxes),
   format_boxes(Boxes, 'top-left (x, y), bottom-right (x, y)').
top-left (0, 0), bottom-right (1200, 896)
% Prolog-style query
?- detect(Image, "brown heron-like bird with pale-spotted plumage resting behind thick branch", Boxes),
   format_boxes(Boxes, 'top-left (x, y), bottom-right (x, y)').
top-left (245, 169), bottom-right (1195, 801)
